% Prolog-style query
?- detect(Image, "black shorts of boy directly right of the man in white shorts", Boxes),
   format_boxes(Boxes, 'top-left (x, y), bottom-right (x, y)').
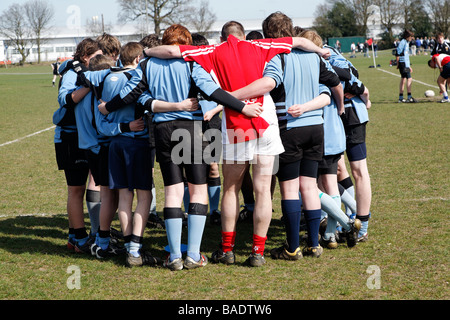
top-left (280, 124), bottom-right (324, 166)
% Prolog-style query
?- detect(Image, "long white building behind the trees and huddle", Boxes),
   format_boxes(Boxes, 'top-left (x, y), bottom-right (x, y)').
top-left (0, 18), bottom-right (314, 63)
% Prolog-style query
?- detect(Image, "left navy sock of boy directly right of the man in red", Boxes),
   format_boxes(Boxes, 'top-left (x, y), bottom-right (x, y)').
top-left (281, 200), bottom-right (302, 253)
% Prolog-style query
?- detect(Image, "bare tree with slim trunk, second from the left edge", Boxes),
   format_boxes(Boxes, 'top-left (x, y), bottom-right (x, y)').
top-left (23, 0), bottom-right (55, 63)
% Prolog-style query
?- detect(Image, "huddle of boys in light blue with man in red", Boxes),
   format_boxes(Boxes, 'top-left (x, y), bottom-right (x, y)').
top-left (54, 12), bottom-right (370, 270)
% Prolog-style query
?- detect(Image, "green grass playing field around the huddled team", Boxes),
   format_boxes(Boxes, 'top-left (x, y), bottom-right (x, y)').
top-left (0, 51), bottom-right (450, 300)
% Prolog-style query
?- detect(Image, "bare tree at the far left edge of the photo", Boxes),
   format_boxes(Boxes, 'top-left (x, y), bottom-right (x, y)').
top-left (0, 4), bottom-right (31, 65)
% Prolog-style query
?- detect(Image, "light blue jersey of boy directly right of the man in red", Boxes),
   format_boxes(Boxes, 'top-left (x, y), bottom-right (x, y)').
top-left (264, 50), bottom-right (329, 130)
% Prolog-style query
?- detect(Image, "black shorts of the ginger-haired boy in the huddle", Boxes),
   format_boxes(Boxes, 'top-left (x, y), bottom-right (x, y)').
top-left (155, 120), bottom-right (209, 186)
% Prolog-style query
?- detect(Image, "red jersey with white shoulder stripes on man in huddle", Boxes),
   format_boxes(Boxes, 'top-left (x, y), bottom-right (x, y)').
top-left (180, 35), bottom-right (292, 143)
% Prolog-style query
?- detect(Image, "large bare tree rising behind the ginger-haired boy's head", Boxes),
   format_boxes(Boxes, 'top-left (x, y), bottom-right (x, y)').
top-left (117, 0), bottom-right (192, 36)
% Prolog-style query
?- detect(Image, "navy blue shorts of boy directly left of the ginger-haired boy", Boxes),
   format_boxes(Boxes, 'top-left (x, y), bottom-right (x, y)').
top-left (109, 136), bottom-right (152, 190)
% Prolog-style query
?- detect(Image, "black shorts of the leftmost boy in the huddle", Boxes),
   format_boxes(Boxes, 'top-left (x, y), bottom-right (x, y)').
top-left (55, 132), bottom-right (89, 186)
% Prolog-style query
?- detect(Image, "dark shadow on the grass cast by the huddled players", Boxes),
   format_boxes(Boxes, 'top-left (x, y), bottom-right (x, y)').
top-left (0, 213), bottom-right (284, 265)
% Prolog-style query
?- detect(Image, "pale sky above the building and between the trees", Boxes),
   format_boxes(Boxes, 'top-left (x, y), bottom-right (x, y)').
top-left (0, 0), bottom-right (326, 26)
